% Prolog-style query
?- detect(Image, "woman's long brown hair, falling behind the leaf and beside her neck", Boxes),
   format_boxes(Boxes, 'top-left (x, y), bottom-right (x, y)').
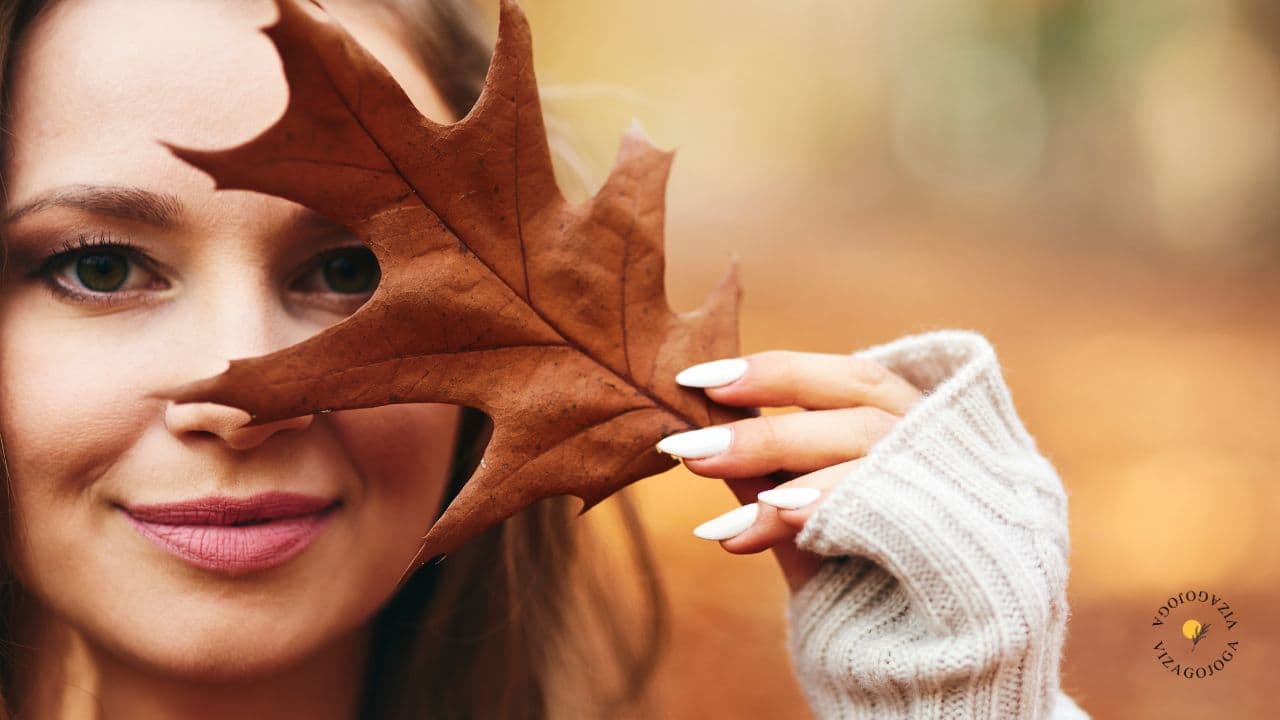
top-left (0, 0), bottom-right (668, 720)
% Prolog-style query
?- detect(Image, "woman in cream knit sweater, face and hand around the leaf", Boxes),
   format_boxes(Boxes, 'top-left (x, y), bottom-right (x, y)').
top-left (0, 0), bottom-right (1090, 719)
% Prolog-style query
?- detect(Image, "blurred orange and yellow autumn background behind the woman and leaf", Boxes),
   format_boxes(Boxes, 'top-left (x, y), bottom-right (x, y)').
top-left (483, 0), bottom-right (1280, 720)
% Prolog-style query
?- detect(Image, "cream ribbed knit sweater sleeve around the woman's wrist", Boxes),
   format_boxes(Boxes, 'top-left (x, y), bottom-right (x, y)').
top-left (787, 329), bottom-right (1088, 720)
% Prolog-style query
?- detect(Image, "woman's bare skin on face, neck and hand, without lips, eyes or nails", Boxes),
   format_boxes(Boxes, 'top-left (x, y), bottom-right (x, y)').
top-left (0, 0), bottom-right (920, 720)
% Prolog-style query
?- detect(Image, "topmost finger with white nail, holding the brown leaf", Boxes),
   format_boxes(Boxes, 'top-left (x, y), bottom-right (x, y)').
top-left (676, 350), bottom-right (923, 416)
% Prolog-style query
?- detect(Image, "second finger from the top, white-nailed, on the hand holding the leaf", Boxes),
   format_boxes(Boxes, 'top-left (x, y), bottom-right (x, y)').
top-left (658, 407), bottom-right (899, 480)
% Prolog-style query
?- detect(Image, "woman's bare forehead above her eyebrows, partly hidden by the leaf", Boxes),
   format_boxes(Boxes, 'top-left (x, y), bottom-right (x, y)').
top-left (5, 0), bottom-right (447, 200)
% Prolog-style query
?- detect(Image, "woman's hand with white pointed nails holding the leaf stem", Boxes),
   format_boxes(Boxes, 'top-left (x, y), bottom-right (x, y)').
top-left (658, 350), bottom-right (924, 592)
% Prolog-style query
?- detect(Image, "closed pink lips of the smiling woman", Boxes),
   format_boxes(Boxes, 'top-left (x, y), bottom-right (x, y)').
top-left (123, 492), bottom-right (339, 575)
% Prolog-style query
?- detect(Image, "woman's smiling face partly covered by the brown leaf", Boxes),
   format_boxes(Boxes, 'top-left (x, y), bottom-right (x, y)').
top-left (0, 0), bottom-right (458, 676)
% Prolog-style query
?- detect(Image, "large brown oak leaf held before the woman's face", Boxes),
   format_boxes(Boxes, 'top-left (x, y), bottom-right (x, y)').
top-left (147, 0), bottom-right (758, 560)
